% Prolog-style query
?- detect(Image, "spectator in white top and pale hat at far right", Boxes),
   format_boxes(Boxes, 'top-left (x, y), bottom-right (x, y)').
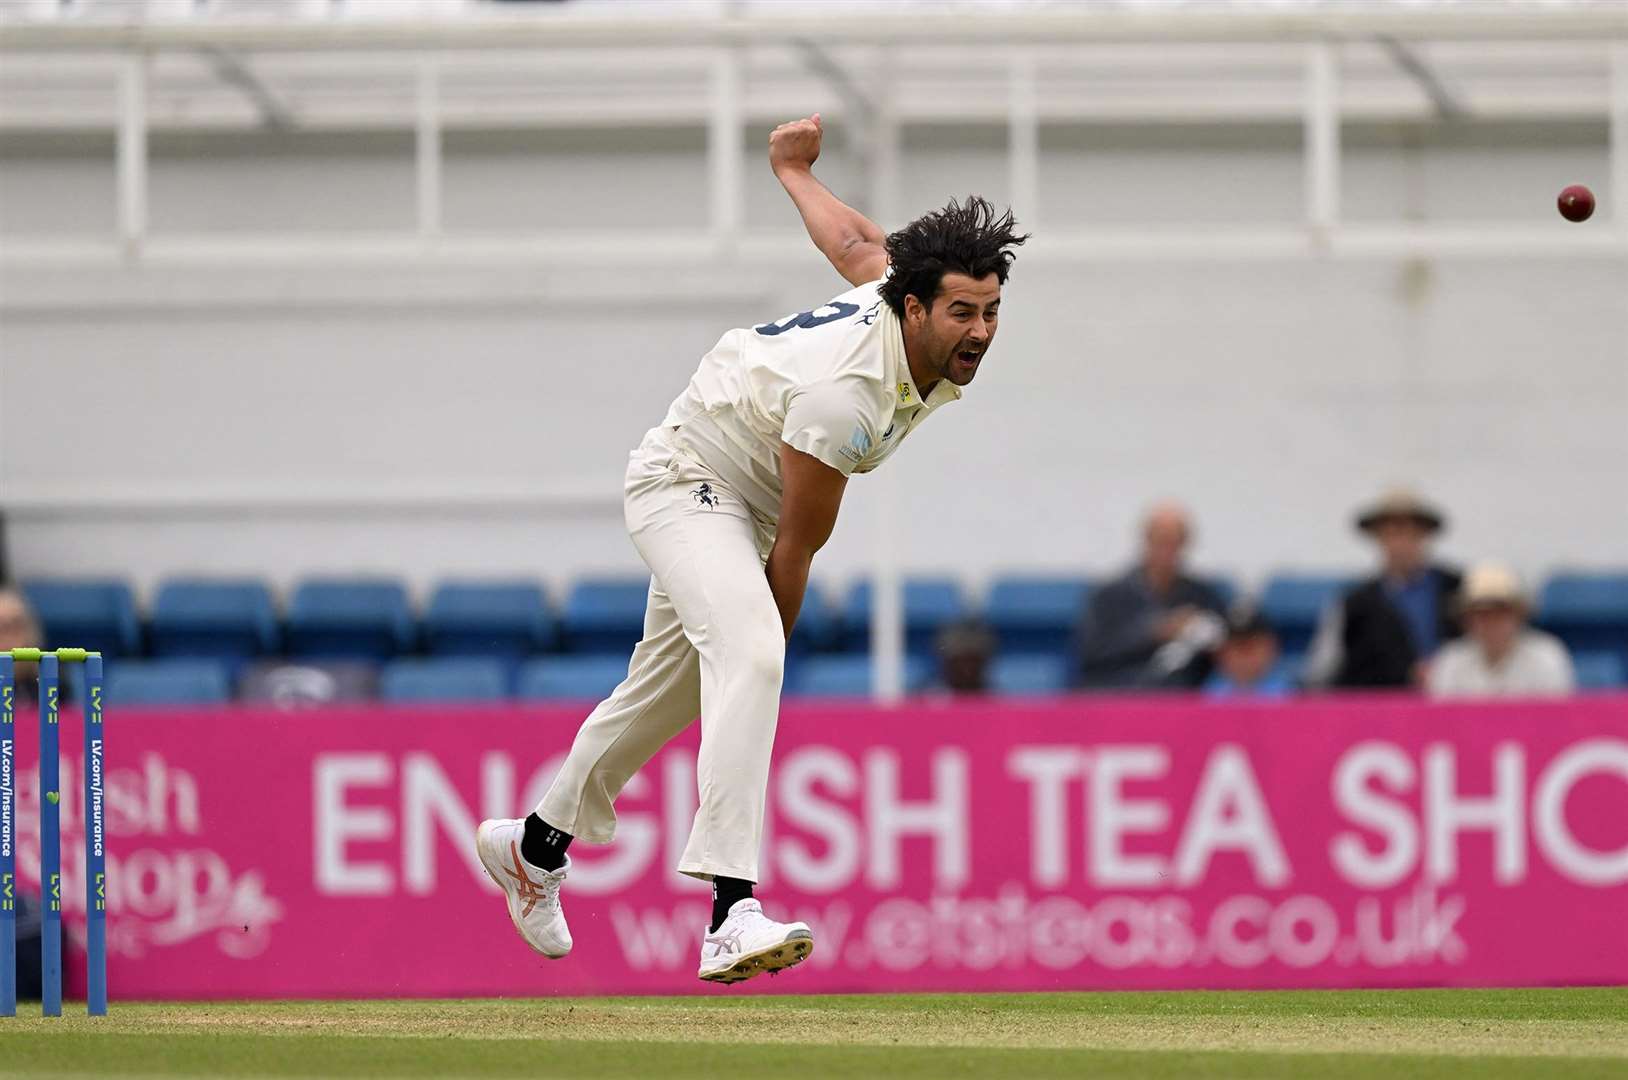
top-left (1429, 562), bottom-right (1576, 697)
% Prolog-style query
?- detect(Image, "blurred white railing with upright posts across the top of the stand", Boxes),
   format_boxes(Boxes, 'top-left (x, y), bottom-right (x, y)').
top-left (0, 0), bottom-right (1628, 264)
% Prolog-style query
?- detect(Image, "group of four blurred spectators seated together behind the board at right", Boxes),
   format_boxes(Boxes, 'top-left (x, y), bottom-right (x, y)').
top-left (1079, 490), bottom-right (1578, 697)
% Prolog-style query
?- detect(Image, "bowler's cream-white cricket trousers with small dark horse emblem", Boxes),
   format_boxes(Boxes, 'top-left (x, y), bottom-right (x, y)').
top-left (537, 428), bottom-right (786, 881)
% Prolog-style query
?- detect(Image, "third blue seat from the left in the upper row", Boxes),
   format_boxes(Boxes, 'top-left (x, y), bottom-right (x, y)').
top-left (288, 578), bottom-right (415, 660)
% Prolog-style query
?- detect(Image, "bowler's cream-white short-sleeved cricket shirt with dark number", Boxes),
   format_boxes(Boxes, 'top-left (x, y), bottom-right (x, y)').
top-left (661, 280), bottom-right (961, 521)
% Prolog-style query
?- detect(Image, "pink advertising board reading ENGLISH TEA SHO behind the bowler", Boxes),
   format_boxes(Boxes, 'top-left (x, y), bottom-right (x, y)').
top-left (18, 697), bottom-right (1628, 1000)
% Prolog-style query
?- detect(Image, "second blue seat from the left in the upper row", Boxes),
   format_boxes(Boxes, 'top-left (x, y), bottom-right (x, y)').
top-left (150, 578), bottom-right (278, 661)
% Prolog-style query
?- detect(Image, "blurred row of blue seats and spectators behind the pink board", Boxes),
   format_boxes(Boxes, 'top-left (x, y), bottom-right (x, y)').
top-left (0, 492), bottom-right (1628, 702)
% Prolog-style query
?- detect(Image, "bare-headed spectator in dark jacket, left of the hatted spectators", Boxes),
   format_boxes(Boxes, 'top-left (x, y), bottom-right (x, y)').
top-left (1079, 503), bottom-right (1224, 687)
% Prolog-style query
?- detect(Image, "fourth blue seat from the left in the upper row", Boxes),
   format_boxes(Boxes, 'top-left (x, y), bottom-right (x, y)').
top-left (423, 582), bottom-right (555, 660)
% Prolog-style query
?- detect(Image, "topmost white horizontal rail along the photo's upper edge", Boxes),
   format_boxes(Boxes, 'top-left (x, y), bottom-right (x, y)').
top-left (7, 0), bottom-right (1625, 49)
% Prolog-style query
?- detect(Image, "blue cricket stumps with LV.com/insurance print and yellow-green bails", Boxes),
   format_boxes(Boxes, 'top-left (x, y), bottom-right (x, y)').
top-left (0, 648), bottom-right (107, 1016)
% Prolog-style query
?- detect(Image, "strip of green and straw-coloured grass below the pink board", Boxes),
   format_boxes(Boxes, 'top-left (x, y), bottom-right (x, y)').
top-left (0, 987), bottom-right (1628, 1080)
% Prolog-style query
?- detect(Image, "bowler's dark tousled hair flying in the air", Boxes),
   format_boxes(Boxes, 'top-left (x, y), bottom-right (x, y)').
top-left (881, 195), bottom-right (1029, 316)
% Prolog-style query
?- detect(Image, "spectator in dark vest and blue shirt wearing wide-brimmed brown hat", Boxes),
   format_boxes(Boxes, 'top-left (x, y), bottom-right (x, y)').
top-left (1306, 490), bottom-right (1462, 687)
